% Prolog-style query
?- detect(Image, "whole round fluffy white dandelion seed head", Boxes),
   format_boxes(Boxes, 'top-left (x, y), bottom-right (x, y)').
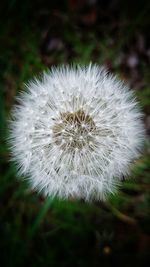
top-left (10, 64), bottom-right (144, 200)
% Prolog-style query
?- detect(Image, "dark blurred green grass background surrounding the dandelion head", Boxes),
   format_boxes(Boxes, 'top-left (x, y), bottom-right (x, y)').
top-left (0, 0), bottom-right (150, 267)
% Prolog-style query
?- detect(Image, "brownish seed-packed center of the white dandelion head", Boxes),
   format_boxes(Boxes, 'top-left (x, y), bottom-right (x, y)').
top-left (52, 110), bottom-right (96, 151)
